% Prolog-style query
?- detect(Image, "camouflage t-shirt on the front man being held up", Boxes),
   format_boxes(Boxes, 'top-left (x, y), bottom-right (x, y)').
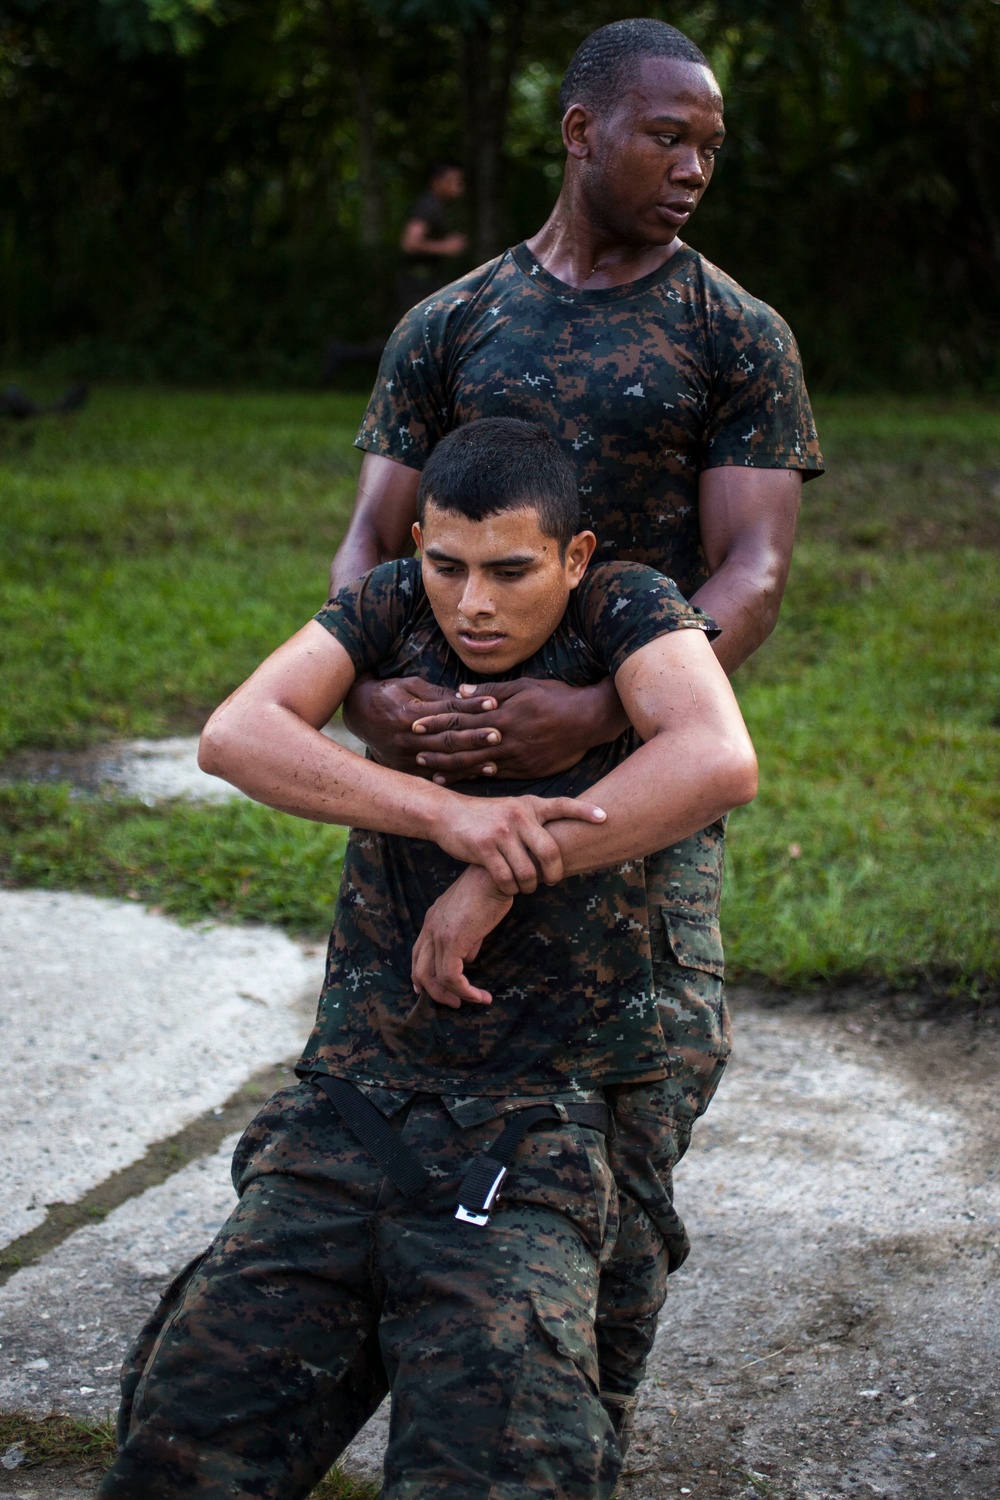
top-left (298, 558), bottom-right (715, 1095)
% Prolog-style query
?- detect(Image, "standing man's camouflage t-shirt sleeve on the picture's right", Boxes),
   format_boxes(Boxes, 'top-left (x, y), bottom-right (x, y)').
top-left (703, 297), bottom-right (823, 479)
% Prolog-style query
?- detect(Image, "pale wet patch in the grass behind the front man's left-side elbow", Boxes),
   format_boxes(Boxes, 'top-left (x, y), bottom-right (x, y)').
top-left (0, 720), bottom-right (364, 807)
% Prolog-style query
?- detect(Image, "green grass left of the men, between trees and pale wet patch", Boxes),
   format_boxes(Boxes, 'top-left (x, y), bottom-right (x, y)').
top-left (0, 390), bottom-right (363, 755)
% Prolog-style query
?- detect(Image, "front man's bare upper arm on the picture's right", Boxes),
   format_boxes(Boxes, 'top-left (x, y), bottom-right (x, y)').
top-left (615, 629), bottom-right (742, 740)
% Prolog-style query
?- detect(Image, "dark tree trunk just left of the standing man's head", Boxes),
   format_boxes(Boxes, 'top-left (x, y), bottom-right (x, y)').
top-left (460, 0), bottom-right (526, 261)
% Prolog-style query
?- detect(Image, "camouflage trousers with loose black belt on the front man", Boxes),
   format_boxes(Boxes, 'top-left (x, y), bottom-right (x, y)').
top-left (99, 1083), bottom-right (621, 1500)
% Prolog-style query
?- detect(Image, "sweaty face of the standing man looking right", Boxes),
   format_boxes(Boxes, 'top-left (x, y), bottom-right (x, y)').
top-left (580, 57), bottom-right (726, 245)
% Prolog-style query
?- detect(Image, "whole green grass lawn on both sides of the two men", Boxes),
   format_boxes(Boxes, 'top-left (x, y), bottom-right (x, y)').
top-left (0, 390), bottom-right (1000, 993)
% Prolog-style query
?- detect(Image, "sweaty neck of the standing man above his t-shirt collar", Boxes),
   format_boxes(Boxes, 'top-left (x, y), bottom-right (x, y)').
top-left (526, 186), bottom-right (684, 291)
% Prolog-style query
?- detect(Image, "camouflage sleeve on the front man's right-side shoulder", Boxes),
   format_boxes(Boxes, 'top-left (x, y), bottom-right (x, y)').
top-left (579, 563), bottom-right (720, 677)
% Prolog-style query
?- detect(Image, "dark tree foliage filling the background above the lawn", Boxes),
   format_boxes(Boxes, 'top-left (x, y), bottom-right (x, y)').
top-left (0, 0), bottom-right (1000, 386)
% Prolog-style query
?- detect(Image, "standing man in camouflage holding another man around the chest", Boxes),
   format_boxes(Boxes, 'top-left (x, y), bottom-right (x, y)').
top-left (331, 11), bottom-right (822, 1446)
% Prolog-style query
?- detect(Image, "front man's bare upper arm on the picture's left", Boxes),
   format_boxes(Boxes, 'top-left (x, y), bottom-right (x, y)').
top-left (231, 620), bottom-right (355, 729)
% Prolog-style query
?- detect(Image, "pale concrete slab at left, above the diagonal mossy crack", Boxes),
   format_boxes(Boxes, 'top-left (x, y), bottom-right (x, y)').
top-left (0, 891), bottom-right (322, 1245)
